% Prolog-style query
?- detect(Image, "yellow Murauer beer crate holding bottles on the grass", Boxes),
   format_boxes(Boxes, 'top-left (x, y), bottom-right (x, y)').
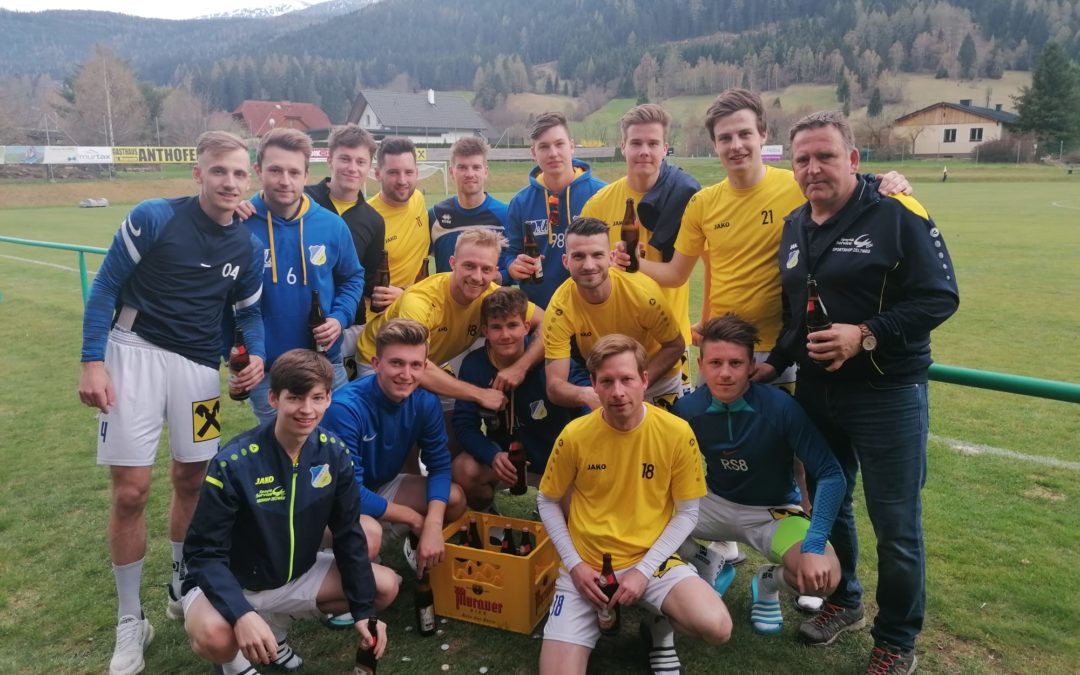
top-left (431, 511), bottom-right (558, 634)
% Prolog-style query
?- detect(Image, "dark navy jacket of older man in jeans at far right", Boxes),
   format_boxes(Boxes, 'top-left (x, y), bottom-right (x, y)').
top-left (768, 176), bottom-right (960, 383)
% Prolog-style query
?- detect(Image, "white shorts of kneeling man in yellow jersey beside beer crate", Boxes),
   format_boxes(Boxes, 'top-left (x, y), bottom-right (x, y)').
top-left (543, 557), bottom-right (698, 649)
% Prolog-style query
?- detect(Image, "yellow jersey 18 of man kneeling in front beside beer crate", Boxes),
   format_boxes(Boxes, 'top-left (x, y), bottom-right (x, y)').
top-left (540, 403), bottom-right (705, 569)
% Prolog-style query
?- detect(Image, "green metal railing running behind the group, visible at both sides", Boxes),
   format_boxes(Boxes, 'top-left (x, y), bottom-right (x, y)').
top-left (0, 237), bottom-right (1080, 403)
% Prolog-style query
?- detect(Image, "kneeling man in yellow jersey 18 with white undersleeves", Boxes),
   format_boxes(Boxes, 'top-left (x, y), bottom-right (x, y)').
top-left (537, 335), bottom-right (731, 675)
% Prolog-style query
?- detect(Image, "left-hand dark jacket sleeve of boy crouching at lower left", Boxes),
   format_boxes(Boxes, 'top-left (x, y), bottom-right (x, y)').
top-left (184, 455), bottom-right (254, 625)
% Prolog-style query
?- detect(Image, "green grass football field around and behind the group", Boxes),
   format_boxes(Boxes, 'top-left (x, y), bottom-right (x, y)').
top-left (0, 161), bottom-right (1080, 674)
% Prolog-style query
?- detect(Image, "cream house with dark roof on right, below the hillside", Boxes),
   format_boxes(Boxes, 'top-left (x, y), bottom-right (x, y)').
top-left (894, 98), bottom-right (1020, 157)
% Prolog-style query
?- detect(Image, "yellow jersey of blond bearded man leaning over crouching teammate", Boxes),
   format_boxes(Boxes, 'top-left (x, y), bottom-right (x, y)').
top-left (356, 272), bottom-right (536, 364)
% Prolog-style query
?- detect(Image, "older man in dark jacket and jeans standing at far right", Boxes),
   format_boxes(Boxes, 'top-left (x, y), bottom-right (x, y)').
top-left (755, 112), bottom-right (959, 674)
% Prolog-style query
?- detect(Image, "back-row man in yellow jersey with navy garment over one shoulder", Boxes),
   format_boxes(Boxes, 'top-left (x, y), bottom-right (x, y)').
top-left (581, 103), bottom-right (701, 356)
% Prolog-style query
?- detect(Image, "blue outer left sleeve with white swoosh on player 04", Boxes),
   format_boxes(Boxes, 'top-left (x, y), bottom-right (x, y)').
top-left (81, 201), bottom-right (173, 363)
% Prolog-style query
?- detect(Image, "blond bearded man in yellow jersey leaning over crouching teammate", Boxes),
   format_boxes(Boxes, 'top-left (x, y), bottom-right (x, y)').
top-left (356, 230), bottom-right (543, 410)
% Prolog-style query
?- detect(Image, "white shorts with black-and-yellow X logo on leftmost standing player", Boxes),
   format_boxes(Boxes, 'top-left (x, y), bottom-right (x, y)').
top-left (97, 327), bottom-right (221, 467)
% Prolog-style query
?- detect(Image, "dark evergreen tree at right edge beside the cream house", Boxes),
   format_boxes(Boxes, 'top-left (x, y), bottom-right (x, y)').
top-left (1015, 42), bottom-right (1080, 143)
